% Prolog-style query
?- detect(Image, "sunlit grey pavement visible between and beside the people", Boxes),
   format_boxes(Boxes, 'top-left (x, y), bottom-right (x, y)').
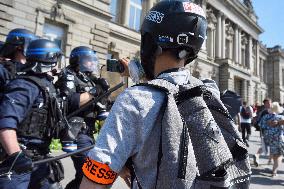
top-left (57, 129), bottom-right (284, 189)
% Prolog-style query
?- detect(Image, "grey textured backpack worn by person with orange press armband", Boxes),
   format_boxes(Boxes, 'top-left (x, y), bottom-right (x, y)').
top-left (131, 77), bottom-right (251, 189)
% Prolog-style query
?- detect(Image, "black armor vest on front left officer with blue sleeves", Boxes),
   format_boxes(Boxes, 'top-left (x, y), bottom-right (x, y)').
top-left (17, 76), bottom-right (58, 145)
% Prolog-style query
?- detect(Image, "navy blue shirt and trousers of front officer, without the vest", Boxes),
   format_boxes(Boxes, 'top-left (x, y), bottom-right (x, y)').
top-left (0, 72), bottom-right (80, 189)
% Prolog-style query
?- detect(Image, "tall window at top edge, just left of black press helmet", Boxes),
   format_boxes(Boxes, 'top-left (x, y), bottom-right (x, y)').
top-left (128, 0), bottom-right (142, 31)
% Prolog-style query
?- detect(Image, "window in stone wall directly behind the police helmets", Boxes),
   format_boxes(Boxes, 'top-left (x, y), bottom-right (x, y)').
top-left (43, 22), bottom-right (66, 51)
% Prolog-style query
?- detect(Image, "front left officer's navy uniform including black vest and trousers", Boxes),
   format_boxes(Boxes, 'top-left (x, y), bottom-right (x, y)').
top-left (0, 71), bottom-right (79, 188)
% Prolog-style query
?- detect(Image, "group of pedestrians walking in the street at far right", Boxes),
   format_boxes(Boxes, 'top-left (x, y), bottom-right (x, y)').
top-left (239, 98), bottom-right (284, 177)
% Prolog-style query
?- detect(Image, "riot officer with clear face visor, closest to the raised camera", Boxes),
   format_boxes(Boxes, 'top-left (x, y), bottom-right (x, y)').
top-left (55, 46), bottom-right (109, 189)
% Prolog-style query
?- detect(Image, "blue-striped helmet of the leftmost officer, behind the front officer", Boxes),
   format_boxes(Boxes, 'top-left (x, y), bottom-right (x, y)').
top-left (0, 28), bottom-right (38, 57)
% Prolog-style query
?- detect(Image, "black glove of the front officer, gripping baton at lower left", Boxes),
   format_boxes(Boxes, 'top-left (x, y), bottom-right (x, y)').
top-left (0, 151), bottom-right (33, 174)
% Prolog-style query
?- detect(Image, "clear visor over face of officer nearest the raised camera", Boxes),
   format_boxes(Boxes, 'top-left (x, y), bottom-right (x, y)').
top-left (78, 54), bottom-right (99, 74)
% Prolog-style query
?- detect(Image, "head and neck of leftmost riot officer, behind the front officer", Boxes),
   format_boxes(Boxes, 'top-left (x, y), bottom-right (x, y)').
top-left (0, 28), bottom-right (37, 77)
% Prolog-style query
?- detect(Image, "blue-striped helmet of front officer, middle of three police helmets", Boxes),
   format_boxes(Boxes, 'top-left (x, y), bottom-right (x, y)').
top-left (26, 39), bottom-right (62, 72)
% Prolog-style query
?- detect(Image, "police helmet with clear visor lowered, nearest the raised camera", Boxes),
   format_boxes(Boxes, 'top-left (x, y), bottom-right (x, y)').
top-left (69, 46), bottom-right (99, 74)
